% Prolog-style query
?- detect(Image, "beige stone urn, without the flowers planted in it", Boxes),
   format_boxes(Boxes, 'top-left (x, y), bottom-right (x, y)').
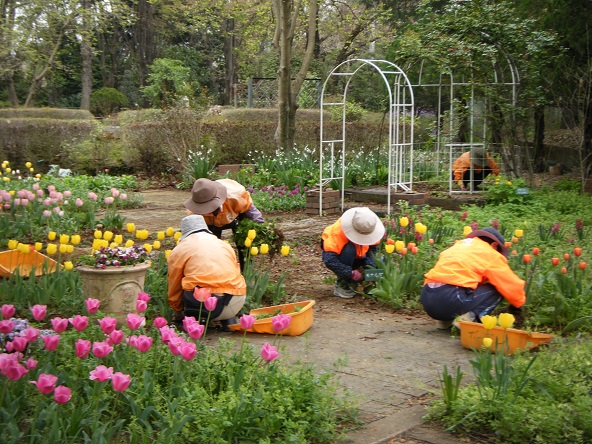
top-left (76, 262), bottom-right (151, 324)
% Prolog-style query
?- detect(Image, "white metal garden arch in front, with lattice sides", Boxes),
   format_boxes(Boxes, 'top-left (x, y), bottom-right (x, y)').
top-left (319, 59), bottom-right (415, 215)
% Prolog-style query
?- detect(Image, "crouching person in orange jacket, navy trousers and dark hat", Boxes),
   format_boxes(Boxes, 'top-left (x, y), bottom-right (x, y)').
top-left (421, 227), bottom-right (526, 329)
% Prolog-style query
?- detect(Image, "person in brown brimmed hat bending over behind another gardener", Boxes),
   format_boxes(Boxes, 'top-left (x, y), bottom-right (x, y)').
top-left (183, 178), bottom-right (265, 270)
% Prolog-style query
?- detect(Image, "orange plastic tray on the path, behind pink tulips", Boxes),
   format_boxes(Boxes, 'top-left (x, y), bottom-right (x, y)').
top-left (228, 301), bottom-right (316, 336)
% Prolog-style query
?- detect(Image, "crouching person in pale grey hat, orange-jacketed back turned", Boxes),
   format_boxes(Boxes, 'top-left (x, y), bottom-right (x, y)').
top-left (167, 214), bottom-right (247, 327)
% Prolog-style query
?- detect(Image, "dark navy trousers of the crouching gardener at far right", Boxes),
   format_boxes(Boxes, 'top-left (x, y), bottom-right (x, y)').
top-left (420, 284), bottom-right (503, 321)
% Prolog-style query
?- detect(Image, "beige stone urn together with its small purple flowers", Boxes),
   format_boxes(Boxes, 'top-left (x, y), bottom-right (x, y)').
top-left (76, 245), bottom-right (152, 322)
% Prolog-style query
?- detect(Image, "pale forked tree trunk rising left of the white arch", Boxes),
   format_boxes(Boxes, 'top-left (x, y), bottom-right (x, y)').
top-left (272, 0), bottom-right (318, 149)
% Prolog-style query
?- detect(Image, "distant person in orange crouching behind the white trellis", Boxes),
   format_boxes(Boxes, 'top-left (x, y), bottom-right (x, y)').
top-left (452, 146), bottom-right (499, 191)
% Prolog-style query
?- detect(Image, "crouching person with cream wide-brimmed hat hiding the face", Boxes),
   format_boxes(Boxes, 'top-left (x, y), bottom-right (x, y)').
top-left (321, 207), bottom-right (385, 298)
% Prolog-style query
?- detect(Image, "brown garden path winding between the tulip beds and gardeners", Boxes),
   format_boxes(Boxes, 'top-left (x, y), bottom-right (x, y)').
top-left (122, 189), bottom-right (486, 444)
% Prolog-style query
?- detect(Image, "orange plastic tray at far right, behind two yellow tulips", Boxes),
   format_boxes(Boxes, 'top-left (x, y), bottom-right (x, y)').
top-left (459, 321), bottom-right (554, 355)
